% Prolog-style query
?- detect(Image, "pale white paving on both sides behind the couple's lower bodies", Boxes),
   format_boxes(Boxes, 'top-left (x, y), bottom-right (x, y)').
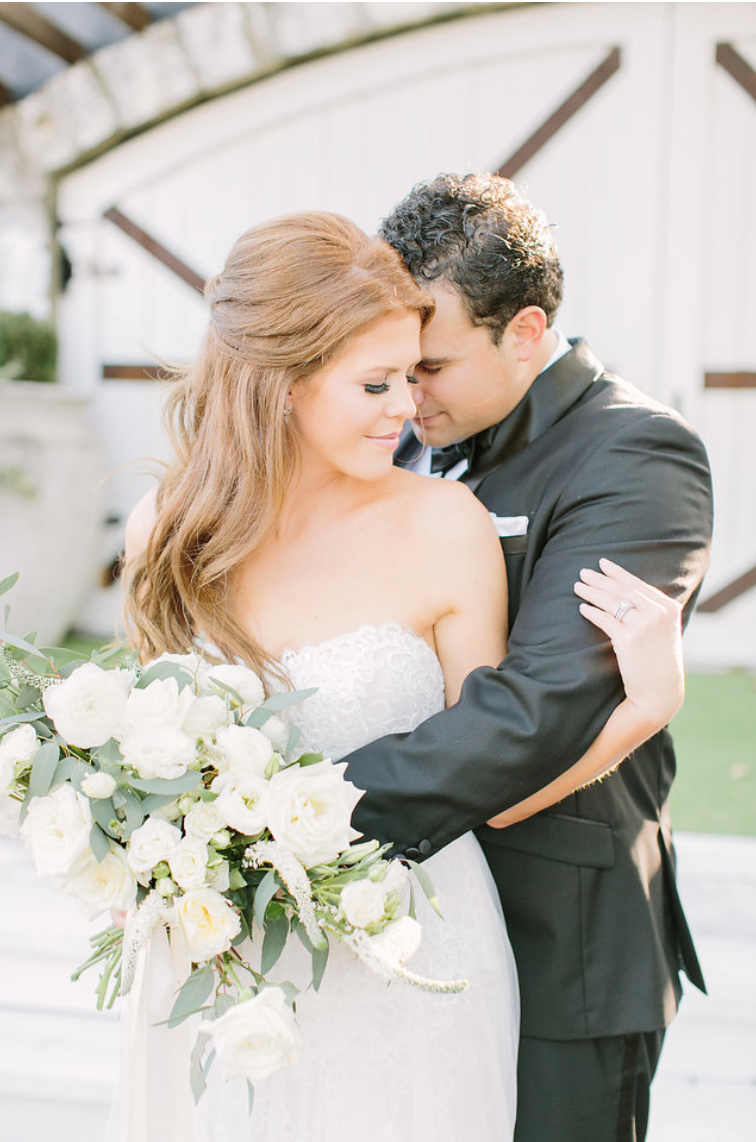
top-left (0, 834), bottom-right (756, 1142)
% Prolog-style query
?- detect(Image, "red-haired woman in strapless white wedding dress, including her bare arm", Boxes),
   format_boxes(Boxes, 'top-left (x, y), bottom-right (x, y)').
top-left (120, 214), bottom-right (681, 1142)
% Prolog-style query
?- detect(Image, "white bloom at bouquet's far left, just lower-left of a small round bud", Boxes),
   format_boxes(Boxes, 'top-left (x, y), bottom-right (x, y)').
top-left (21, 785), bottom-right (91, 879)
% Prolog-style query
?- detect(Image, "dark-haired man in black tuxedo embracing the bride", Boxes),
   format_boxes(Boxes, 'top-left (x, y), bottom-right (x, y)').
top-left (348, 176), bottom-right (711, 1142)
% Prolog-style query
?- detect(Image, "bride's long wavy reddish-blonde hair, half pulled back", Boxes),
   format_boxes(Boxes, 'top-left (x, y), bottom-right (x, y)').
top-left (124, 212), bottom-right (433, 673)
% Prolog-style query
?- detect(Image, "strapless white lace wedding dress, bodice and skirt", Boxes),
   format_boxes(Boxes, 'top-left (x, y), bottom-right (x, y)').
top-left (121, 622), bottom-right (518, 1142)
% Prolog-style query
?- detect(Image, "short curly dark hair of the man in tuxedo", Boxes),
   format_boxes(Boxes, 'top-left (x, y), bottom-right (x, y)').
top-left (379, 175), bottom-right (564, 345)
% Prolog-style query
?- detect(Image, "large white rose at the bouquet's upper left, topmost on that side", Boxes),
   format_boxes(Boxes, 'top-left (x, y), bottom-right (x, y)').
top-left (42, 662), bottom-right (134, 749)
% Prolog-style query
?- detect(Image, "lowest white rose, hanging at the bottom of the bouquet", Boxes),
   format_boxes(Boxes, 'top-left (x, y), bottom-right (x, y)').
top-left (210, 988), bottom-right (299, 1083)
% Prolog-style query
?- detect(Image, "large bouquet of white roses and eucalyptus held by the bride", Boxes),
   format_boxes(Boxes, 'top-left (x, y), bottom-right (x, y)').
top-left (0, 576), bottom-right (466, 1097)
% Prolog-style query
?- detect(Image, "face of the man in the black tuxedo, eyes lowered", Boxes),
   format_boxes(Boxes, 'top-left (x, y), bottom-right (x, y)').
top-left (412, 281), bottom-right (529, 448)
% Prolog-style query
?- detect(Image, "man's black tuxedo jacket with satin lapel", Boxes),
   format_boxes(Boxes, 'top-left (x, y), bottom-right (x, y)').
top-left (347, 340), bottom-right (711, 1039)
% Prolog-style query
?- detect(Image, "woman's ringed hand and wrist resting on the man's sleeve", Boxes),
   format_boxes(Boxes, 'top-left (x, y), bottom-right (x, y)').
top-left (574, 558), bottom-right (685, 732)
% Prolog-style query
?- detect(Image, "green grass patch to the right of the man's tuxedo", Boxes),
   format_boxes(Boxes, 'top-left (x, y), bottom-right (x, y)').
top-left (670, 670), bottom-right (756, 836)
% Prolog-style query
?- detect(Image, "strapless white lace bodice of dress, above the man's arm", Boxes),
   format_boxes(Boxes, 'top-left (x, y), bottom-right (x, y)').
top-left (275, 622), bottom-right (444, 759)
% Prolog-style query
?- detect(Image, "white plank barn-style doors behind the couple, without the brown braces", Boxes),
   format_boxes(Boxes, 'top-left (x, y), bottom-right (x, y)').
top-left (58, 3), bottom-right (756, 664)
